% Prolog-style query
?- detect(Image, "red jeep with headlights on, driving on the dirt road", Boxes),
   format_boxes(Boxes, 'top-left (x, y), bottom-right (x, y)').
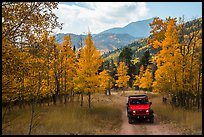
top-left (127, 95), bottom-right (154, 124)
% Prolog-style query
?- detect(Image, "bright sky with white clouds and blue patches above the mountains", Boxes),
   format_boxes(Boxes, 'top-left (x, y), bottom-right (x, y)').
top-left (54, 2), bottom-right (202, 34)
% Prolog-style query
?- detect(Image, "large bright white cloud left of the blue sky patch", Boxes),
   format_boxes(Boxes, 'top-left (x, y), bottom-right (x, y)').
top-left (54, 2), bottom-right (148, 34)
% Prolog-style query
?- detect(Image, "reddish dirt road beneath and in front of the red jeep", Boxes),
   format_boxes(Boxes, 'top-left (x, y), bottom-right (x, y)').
top-left (114, 91), bottom-right (182, 135)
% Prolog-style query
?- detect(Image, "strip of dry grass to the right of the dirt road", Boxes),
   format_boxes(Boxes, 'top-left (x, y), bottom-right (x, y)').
top-left (152, 97), bottom-right (202, 135)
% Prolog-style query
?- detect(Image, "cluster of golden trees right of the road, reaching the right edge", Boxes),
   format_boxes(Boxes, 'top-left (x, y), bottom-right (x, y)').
top-left (134, 17), bottom-right (202, 108)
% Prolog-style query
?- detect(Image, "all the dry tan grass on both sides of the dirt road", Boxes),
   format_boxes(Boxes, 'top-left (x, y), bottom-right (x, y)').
top-left (2, 90), bottom-right (202, 135)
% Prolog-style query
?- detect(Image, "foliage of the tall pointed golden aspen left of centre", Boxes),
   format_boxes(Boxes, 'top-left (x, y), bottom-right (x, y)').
top-left (74, 33), bottom-right (103, 94)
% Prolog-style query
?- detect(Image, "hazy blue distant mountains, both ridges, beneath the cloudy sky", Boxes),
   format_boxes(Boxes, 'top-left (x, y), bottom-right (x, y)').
top-left (55, 18), bottom-right (153, 53)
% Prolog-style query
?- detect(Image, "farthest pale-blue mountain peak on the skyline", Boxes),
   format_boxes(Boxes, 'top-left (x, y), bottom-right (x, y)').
top-left (99, 18), bottom-right (153, 38)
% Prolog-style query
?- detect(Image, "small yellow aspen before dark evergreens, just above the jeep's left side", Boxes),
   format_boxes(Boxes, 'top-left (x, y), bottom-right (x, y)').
top-left (115, 62), bottom-right (130, 88)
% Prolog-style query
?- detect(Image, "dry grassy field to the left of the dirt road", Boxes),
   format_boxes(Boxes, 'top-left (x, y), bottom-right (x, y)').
top-left (2, 94), bottom-right (122, 135)
